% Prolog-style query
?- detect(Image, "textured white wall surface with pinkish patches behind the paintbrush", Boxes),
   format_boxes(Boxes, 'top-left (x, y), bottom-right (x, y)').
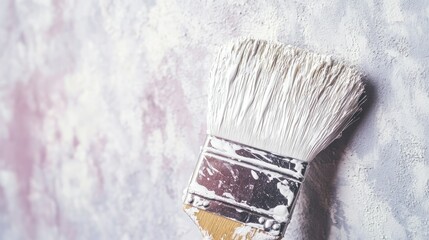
top-left (0, 0), bottom-right (429, 240)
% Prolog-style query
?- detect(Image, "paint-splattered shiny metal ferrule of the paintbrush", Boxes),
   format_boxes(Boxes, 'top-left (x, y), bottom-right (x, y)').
top-left (184, 135), bottom-right (308, 236)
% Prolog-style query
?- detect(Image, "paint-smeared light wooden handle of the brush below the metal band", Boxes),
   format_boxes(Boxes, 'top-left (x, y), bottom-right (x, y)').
top-left (184, 205), bottom-right (280, 240)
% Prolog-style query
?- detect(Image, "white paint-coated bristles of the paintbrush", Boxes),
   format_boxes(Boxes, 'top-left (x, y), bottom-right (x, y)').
top-left (208, 39), bottom-right (364, 161)
